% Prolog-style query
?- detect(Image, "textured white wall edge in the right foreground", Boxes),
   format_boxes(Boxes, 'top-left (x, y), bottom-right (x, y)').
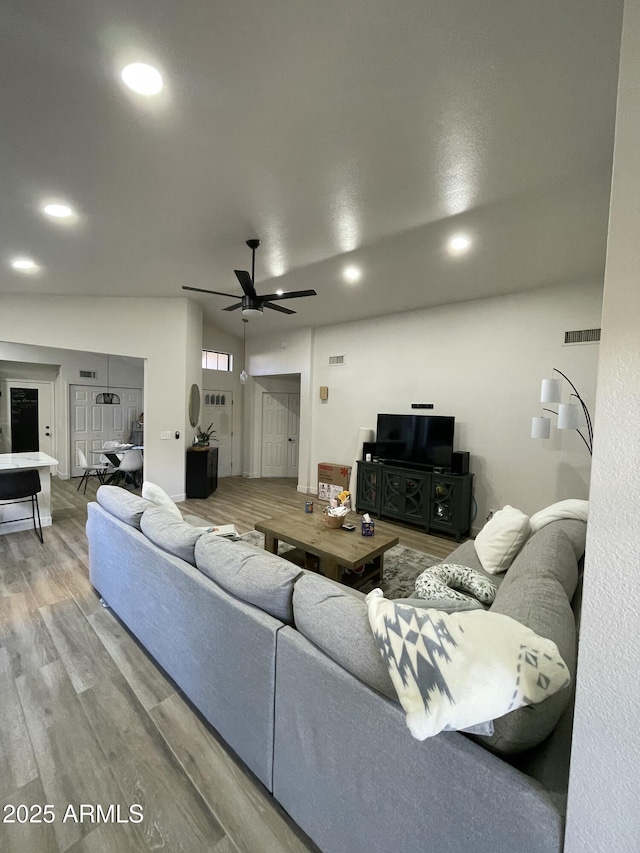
top-left (565, 0), bottom-right (640, 853)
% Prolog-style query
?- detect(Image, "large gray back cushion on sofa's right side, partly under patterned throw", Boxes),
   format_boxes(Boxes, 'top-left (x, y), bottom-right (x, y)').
top-left (483, 522), bottom-right (578, 753)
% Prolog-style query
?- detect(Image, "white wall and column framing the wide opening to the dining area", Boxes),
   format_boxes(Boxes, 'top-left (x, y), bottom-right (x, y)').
top-left (0, 295), bottom-right (202, 500)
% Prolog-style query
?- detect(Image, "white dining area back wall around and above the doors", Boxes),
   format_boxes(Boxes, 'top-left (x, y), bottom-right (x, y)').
top-left (0, 341), bottom-right (144, 478)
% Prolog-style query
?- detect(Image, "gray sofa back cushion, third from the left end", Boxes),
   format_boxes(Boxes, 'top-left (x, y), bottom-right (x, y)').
top-left (195, 533), bottom-right (300, 625)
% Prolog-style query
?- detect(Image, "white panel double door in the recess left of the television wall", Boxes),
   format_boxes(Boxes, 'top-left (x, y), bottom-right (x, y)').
top-left (260, 392), bottom-right (300, 477)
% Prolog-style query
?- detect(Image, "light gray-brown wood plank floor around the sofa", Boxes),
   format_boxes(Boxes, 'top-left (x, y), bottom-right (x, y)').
top-left (0, 477), bottom-right (455, 853)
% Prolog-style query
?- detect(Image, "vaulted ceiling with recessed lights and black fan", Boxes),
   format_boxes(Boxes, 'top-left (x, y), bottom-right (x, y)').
top-left (0, 0), bottom-right (622, 334)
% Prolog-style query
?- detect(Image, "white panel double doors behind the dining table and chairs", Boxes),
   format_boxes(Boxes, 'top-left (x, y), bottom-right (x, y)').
top-left (69, 385), bottom-right (143, 477)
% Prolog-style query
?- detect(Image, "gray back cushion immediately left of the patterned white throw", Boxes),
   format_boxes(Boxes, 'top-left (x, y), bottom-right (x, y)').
top-left (293, 573), bottom-right (398, 701)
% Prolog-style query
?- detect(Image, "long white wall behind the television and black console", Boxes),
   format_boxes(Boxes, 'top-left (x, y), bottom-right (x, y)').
top-left (247, 282), bottom-right (602, 527)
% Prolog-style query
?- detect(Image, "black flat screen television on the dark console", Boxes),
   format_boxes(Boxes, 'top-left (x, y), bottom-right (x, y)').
top-left (376, 415), bottom-right (455, 468)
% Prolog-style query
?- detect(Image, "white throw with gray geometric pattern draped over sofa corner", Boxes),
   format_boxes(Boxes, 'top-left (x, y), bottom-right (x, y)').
top-left (364, 588), bottom-right (571, 740)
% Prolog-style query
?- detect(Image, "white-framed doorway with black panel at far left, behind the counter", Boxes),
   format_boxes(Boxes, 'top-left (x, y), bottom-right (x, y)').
top-left (0, 379), bottom-right (55, 456)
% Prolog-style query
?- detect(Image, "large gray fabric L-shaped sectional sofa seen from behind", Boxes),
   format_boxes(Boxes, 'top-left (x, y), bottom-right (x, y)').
top-left (87, 486), bottom-right (586, 853)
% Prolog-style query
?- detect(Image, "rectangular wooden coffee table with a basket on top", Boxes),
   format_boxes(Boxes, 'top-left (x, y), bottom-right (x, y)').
top-left (255, 511), bottom-right (399, 587)
